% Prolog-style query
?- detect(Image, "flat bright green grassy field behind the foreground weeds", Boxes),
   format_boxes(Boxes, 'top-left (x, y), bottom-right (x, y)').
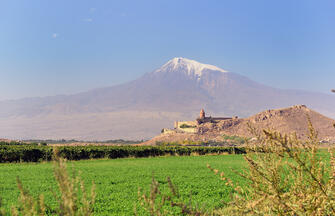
top-left (0, 155), bottom-right (245, 215)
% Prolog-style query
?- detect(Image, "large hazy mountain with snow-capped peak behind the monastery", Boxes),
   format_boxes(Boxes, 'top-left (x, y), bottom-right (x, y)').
top-left (0, 58), bottom-right (335, 140)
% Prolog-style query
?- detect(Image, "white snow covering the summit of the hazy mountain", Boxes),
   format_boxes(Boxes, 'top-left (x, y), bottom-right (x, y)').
top-left (155, 57), bottom-right (227, 77)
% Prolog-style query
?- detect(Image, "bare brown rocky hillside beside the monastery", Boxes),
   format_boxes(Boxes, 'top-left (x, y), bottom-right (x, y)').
top-left (143, 105), bottom-right (335, 145)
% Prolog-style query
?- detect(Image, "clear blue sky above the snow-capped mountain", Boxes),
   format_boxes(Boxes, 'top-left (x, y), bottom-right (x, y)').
top-left (0, 0), bottom-right (335, 100)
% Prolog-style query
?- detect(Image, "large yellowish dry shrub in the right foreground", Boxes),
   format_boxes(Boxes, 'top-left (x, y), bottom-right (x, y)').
top-left (140, 121), bottom-right (335, 216)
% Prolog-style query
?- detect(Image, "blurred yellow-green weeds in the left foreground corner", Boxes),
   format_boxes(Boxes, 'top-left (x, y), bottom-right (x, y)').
top-left (6, 151), bottom-right (95, 216)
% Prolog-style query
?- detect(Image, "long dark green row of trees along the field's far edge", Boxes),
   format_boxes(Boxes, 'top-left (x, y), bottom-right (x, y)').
top-left (0, 145), bottom-right (245, 163)
